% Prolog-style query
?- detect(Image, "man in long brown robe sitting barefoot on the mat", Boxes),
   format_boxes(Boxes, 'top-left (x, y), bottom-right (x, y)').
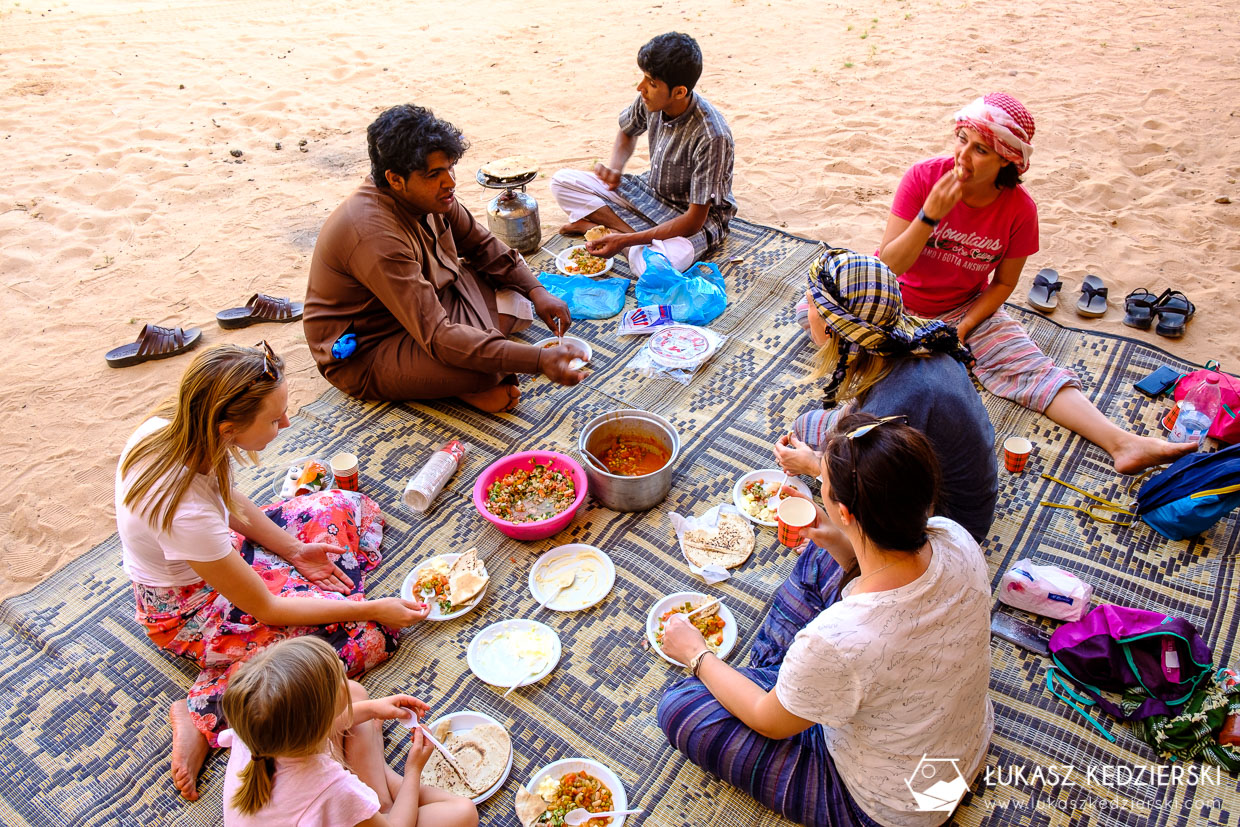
top-left (303, 104), bottom-right (585, 412)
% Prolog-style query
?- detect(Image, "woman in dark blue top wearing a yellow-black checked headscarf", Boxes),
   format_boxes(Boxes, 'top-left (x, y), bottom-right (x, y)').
top-left (775, 249), bottom-right (998, 569)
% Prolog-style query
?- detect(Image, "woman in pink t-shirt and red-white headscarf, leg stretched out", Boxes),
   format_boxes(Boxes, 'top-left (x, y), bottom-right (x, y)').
top-left (879, 94), bottom-right (1192, 474)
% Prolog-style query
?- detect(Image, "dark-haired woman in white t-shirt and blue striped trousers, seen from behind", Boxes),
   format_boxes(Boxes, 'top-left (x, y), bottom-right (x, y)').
top-left (658, 413), bottom-right (993, 827)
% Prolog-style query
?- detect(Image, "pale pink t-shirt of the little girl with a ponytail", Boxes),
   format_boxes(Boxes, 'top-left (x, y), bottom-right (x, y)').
top-left (219, 729), bottom-right (379, 827)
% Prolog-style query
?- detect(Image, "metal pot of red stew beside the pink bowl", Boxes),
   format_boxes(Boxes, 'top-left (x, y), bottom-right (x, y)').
top-left (578, 408), bottom-right (681, 511)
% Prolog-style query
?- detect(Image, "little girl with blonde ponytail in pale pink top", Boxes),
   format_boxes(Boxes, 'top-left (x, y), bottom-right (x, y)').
top-left (219, 636), bottom-right (477, 827)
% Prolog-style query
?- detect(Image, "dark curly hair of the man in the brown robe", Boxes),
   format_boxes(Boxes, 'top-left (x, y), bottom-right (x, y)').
top-left (366, 103), bottom-right (469, 188)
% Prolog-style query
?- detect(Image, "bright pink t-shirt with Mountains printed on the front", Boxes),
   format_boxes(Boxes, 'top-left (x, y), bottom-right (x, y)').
top-left (892, 156), bottom-right (1038, 316)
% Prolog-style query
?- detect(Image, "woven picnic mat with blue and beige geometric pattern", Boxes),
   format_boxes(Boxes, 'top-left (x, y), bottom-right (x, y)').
top-left (0, 221), bottom-right (1240, 827)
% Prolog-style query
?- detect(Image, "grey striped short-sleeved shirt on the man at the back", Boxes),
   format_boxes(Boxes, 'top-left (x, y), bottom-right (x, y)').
top-left (620, 92), bottom-right (737, 248)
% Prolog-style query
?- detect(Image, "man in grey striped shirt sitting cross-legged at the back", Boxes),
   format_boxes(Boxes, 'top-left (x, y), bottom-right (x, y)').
top-left (551, 32), bottom-right (737, 275)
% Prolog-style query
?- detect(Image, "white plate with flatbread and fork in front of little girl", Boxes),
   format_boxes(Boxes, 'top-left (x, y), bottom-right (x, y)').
top-left (422, 709), bottom-right (512, 803)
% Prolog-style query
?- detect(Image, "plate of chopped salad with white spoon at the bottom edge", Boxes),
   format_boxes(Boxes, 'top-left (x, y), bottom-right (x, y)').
top-left (516, 758), bottom-right (629, 827)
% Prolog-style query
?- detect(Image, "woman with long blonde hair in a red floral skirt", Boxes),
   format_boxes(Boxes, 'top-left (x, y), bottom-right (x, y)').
top-left (115, 342), bottom-right (429, 801)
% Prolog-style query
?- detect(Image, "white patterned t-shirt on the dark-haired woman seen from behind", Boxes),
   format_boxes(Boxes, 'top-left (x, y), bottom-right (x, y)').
top-left (775, 517), bottom-right (994, 827)
